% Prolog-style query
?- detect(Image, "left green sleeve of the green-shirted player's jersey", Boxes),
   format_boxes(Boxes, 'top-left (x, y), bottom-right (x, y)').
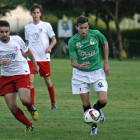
top-left (68, 39), bottom-right (77, 59)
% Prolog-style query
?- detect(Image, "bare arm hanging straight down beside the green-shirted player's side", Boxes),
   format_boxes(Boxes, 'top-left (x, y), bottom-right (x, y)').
top-left (104, 41), bottom-right (109, 76)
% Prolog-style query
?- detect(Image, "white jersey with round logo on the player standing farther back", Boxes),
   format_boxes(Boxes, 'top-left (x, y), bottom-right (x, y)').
top-left (25, 21), bottom-right (55, 61)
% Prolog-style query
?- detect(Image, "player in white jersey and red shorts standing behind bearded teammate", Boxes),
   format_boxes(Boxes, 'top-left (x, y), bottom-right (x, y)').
top-left (25, 4), bottom-right (57, 110)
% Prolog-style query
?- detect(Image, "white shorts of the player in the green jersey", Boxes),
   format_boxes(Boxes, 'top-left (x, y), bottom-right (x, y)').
top-left (72, 68), bottom-right (108, 94)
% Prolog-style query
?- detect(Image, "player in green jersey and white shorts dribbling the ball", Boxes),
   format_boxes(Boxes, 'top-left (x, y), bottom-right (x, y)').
top-left (68, 16), bottom-right (109, 135)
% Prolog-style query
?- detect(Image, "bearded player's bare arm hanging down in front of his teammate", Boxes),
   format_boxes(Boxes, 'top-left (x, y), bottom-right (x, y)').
top-left (26, 48), bottom-right (39, 74)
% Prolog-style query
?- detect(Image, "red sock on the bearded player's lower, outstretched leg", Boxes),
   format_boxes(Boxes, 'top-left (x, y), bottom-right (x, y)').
top-left (13, 108), bottom-right (32, 126)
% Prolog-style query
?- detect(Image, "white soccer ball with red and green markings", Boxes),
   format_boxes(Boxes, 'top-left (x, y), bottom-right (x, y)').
top-left (84, 109), bottom-right (100, 126)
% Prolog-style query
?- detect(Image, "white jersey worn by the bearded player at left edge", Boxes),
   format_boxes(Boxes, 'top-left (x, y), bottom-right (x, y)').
top-left (0, 36), bottom-right (30, 76)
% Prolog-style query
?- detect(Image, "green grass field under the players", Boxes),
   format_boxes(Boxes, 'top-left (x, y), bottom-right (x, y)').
top-left (0, 59), bottom-right (140, 140)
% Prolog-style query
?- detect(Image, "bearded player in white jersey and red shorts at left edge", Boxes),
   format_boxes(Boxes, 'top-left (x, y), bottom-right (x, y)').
top-left (0, 20), bottom-right (39, 131)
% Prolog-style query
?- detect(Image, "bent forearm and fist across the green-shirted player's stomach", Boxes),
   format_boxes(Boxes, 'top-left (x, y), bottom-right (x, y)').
top-left (71, 59), bottom-right (90, 69)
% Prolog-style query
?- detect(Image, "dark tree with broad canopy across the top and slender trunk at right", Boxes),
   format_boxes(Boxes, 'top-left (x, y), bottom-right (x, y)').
top-left (33, 0), bottom-right (140, 60)
